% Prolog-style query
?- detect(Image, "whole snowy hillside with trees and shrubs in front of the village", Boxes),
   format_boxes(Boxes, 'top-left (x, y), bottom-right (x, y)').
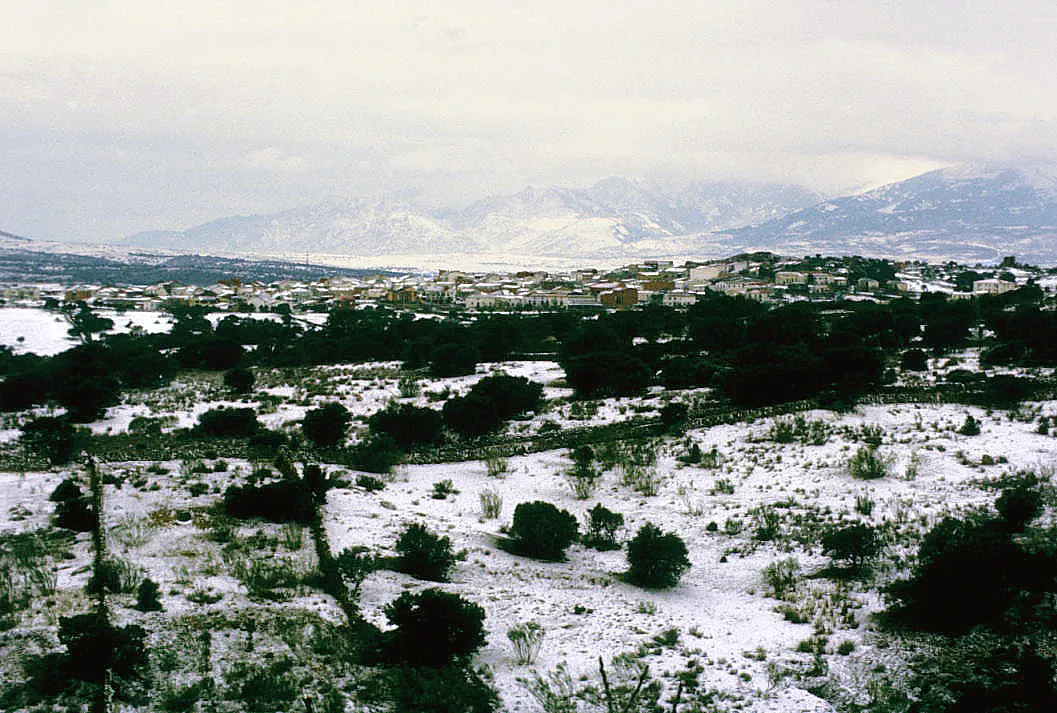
top-left (0, 290), bottom-right (1057, 713)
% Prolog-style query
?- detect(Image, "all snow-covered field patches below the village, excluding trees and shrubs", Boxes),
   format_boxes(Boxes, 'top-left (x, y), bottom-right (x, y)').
top-left (0, 309), bottom-right (1057, 713)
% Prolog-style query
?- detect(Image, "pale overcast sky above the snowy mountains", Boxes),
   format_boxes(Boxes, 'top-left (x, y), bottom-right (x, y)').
top-left (0, 0), bottom-right (1057, 241)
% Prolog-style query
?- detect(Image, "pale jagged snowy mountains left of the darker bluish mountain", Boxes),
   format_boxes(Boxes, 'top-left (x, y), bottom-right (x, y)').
top-left (124, 179), bottom-right (820, 258)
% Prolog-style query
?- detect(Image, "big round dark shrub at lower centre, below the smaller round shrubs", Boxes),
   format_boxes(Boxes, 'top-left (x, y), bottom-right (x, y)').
top-left (385, 588), bottom-right (485, 668)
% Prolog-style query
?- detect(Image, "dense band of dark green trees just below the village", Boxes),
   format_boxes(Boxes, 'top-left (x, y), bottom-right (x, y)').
top-left (0, 286), bottom-right (1057, 423)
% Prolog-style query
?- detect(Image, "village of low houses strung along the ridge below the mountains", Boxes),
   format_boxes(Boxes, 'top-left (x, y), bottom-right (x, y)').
top-left (0, 252), bottom-right (1044, 312)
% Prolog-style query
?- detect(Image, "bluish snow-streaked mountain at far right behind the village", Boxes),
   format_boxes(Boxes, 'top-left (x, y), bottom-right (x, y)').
top-left (728, 167), bottom-right (1057, 264)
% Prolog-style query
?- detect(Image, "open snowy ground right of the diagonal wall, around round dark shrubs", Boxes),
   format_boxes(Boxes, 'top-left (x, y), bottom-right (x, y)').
top-left (327, 405), bottom-right (1057, 711)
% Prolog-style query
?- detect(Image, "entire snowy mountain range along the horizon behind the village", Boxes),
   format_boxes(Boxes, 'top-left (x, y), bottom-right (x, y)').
top-left (18, 167), bottom-right (1057, 266)
